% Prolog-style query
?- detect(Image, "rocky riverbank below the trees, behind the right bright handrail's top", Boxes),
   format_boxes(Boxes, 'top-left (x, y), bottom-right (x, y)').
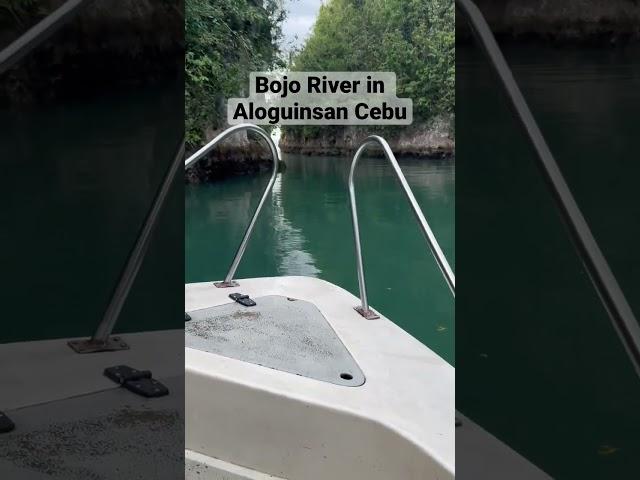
top-left (280, 115), bottom-right (455, 158)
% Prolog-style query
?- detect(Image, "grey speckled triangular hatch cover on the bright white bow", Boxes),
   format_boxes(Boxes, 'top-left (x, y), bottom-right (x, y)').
top-left (185, 295), bottom-right (365, 387)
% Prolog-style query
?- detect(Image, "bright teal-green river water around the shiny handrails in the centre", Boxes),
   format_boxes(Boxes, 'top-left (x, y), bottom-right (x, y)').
top-left (185, 154), bottom-right (455, 363)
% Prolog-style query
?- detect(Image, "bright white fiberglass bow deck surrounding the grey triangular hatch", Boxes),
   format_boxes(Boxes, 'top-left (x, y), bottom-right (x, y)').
top-left (185, 277), bottom-right (455, 480)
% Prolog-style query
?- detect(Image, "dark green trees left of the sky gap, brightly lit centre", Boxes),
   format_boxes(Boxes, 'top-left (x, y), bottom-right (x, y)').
top-left (185, 0), bottom-right (284, 146)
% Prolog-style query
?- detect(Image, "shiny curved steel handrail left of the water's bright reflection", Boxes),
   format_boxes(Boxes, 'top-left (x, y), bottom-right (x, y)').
top-left (184, 123), bottom-right (280, 288)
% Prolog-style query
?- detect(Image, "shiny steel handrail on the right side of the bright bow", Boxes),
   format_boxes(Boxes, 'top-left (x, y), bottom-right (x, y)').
top-left (349, 135), bottom-right (456, 319)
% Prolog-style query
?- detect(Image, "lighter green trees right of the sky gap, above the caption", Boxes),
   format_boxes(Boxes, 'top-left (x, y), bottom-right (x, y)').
top-left (293, 0), bottom-right (455, 121)
